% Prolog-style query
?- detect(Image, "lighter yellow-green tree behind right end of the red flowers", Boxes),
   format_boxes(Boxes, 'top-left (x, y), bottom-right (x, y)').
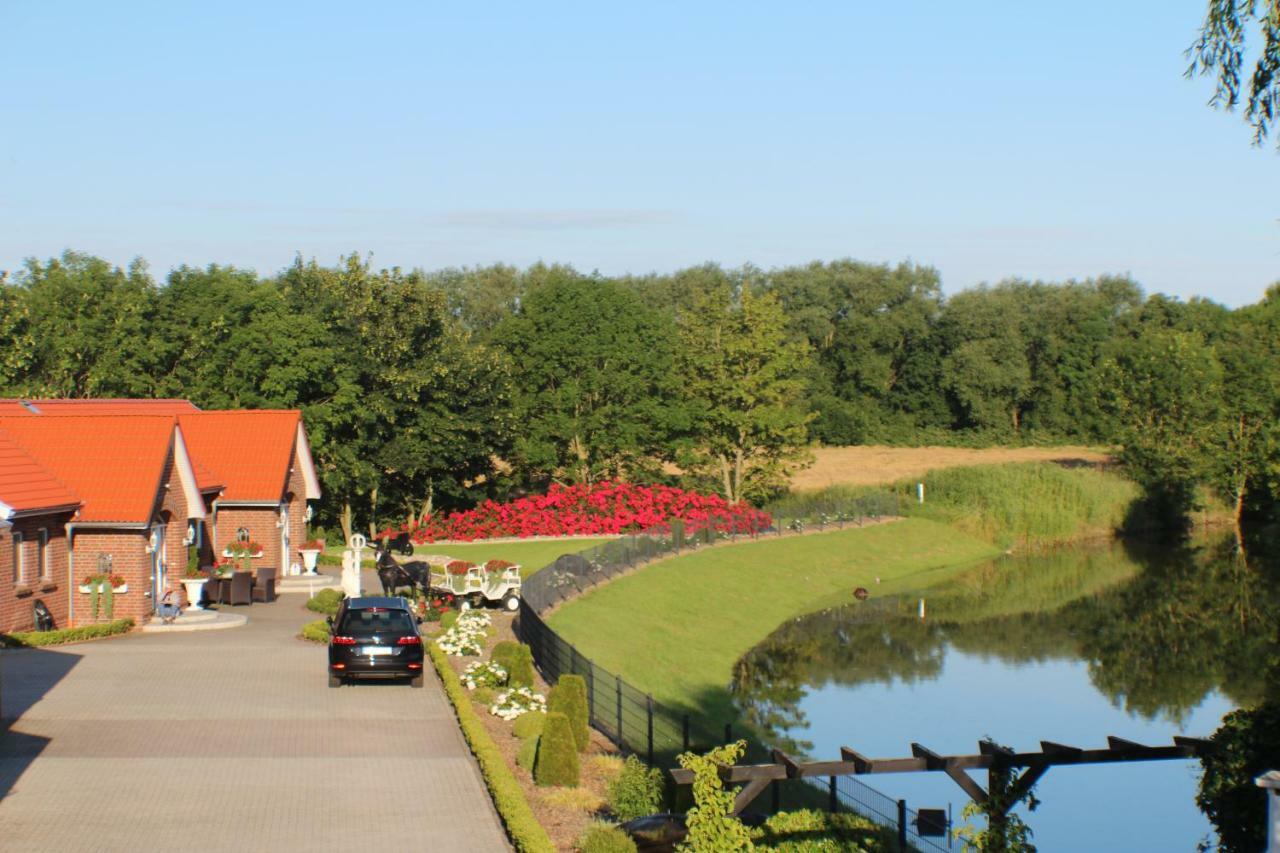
top-left (680, 288), bottom-right (813, 502)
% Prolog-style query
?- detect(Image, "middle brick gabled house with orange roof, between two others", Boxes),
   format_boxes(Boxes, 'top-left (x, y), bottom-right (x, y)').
top-left (0, 412), bottom-right (209, 626)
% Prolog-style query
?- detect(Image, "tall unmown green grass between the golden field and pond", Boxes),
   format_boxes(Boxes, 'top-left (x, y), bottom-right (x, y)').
top-left (768, 462), bottom-right (1139, 549)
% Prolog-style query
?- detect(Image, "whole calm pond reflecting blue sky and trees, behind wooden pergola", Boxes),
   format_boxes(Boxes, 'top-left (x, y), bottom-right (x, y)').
top-left (733, 539), bottom-right (1280, 852)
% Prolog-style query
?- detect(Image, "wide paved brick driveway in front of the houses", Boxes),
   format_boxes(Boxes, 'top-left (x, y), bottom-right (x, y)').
top-left (0, 594), bottom-right (509, 853)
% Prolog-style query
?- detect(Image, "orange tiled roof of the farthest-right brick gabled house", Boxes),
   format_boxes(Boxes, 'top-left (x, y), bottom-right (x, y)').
top-left (178, 409), bottom-right (302, 502)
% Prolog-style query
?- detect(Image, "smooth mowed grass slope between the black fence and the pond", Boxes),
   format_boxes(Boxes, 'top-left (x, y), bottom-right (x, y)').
top-left (548, 519), bottom-right (998, 713)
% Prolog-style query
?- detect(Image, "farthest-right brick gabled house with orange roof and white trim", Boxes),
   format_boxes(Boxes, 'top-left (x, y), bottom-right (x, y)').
top-left (178, 409), bottom-right (320, 576)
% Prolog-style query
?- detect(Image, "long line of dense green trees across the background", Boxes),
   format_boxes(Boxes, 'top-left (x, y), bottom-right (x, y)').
top-left (0, 252), bottom-right (1280, 532)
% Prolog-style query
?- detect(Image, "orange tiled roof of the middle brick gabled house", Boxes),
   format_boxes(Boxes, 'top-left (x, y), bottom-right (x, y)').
top-left (0, 414), bottom-right (174, 524)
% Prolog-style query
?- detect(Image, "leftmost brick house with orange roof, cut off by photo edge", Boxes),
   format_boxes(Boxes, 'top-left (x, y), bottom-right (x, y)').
top-left (0, 432), bottom-right (81, 633)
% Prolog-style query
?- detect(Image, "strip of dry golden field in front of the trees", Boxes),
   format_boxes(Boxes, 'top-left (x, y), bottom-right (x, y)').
top-left (791, 444), bottom-right (1111, 492)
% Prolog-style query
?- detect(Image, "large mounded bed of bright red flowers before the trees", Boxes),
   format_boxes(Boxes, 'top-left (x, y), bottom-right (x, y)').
top-left (380, 483), bottom-right (773, 544)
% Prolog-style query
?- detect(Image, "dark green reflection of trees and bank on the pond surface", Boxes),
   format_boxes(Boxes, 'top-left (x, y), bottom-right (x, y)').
top-left (733, 538), bottom-right (1280, 753)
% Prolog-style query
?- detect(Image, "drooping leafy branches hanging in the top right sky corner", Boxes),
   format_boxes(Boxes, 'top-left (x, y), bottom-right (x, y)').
top-left (1187, 0), bottom-right (1280, 145)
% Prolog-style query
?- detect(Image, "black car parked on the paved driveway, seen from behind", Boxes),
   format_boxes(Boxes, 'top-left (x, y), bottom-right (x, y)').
top-left (329, 596), bottom-right (422, 688)
